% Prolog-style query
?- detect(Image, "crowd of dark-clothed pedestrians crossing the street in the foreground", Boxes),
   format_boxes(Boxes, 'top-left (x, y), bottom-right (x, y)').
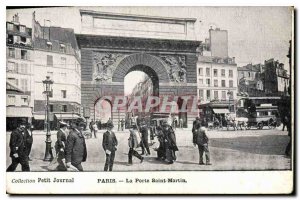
top-left (7, 114), bottom-right (290, 172)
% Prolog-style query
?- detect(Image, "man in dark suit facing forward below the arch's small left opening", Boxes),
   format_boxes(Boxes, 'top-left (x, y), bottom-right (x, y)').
top-left (102, 122), bottom-right (118, 171)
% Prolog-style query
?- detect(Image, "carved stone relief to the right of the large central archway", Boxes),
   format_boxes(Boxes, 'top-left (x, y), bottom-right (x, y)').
top-left (160, 55), bottom-right (186, 83)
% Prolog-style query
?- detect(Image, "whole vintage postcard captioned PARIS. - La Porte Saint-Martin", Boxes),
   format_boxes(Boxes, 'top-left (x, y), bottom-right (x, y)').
top-left (6, 7), bottom-right (295, 194)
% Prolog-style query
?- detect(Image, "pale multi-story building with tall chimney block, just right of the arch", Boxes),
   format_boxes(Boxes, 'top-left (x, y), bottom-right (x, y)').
top-left (197, 28), bottom-right (238, 117)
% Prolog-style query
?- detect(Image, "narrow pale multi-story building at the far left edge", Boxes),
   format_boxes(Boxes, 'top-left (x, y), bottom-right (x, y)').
top-left (6, 14), bottom-right (34, 130)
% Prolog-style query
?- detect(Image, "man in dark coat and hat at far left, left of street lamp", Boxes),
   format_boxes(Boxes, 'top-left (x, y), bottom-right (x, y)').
top-left (6, 119), bottom-right (30, 172)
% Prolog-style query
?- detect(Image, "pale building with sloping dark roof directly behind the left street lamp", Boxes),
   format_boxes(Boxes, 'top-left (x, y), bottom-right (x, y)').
top-left (33, 16), bottom-right (81, 130)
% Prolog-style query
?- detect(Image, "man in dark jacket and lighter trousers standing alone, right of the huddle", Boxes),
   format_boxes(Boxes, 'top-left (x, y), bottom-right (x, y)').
top-left (193, 123), bottom-right (211, 165)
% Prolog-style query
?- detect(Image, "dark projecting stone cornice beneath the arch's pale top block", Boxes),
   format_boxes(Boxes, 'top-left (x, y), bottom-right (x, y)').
top-left (76, 34), bottom-right (201, 53)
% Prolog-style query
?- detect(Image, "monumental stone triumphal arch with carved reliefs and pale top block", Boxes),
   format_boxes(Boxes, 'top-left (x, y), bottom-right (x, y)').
top-left (76, 10), bottom-right (200, 125)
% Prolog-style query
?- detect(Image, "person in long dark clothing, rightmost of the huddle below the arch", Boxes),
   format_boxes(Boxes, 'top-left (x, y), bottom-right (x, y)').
top-left (162, 121), bottom-right (178, 164)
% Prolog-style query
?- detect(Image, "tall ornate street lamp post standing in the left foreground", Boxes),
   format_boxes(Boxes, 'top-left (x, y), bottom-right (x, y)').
top-left (43, 76), bottom-right (53, 161)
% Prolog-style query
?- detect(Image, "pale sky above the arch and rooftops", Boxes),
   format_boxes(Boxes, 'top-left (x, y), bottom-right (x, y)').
top-left (6, 6), bottom-right (292, 93)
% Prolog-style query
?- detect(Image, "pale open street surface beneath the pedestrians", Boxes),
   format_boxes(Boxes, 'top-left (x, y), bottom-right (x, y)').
top-left (6, 127), bottom-right (291, 171)
